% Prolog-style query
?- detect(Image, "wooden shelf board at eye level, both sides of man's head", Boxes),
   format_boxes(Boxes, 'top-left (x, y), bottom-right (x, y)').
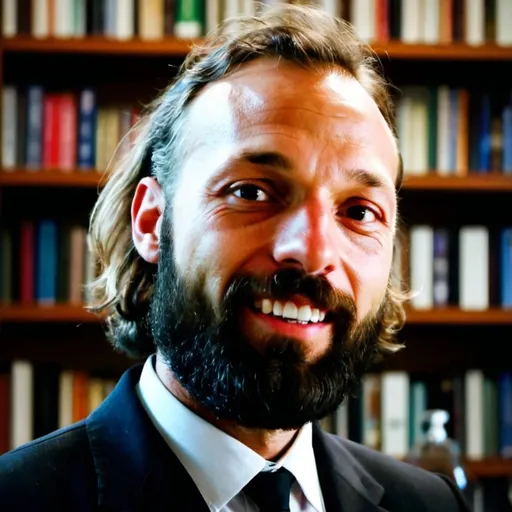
top-left (0, 169), bottom-right (512, 192)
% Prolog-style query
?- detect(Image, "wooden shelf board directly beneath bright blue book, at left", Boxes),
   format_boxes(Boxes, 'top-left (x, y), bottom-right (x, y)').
top-left (0, 304), bottom-right (101, 323)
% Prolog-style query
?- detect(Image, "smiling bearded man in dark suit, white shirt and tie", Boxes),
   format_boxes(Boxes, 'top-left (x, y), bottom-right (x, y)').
top-left (0, 6), bottom-right (472, 512)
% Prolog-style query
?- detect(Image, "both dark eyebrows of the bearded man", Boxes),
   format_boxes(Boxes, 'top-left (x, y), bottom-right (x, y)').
top-left (236, 151), bottom-right (390, 193)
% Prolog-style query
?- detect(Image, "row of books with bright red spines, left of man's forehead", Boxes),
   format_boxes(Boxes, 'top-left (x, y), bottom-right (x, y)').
top-left (2, 85), bottom-right (139, 171)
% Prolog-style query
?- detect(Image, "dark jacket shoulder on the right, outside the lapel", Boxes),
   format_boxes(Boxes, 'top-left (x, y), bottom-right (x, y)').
top-left (332, 436), bottom-right (470, 512)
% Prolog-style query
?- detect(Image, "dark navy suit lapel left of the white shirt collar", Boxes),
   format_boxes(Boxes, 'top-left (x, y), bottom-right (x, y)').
top-left (86, 366), bottom-right (208, 512)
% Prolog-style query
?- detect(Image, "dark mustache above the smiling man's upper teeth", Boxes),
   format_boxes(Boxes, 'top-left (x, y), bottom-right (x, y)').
top-left (226, 269), bottom-right (356, 318)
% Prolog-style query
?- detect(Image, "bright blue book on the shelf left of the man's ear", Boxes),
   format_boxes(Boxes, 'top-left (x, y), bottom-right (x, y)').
top-left (35, 219), bottom-right (58, 304)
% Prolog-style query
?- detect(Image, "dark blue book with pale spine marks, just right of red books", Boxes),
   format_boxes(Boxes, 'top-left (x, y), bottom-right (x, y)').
top-left (78, 89), bottom-right (98, 169)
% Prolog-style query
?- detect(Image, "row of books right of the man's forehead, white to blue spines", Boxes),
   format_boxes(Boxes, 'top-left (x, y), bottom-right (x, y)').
top-left (397, 87), bottom-right (512, 176)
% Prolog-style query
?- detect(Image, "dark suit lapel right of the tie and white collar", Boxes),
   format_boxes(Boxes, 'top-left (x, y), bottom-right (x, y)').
top-left (313, 425), bottom-right (386, 512)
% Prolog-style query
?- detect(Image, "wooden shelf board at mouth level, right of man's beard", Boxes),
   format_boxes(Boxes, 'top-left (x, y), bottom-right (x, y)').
top-left (407, 308), bottom-right (512, 325)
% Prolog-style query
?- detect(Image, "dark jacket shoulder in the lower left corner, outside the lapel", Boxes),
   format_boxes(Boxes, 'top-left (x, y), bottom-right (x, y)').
top-left (0, 422), bottom-right (97, 510)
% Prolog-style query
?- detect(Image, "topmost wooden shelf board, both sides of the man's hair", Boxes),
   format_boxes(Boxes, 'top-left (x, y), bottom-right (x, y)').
top-left (0, 36), bottom-right (512, 61)
